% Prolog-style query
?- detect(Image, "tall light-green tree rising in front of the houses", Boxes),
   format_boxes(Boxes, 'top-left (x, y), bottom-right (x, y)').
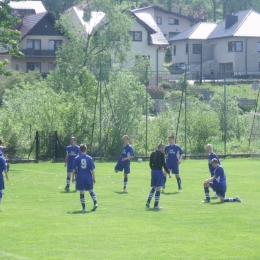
top-left (48, 0), bottom-right (132, 91)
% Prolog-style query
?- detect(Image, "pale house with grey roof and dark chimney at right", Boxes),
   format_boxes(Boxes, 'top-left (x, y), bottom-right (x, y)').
top-left (169, 10), bottom-right (260, 78)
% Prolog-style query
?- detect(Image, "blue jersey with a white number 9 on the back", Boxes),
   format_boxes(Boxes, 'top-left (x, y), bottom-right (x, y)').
top-left (73, 154), bottom-right (95, 184)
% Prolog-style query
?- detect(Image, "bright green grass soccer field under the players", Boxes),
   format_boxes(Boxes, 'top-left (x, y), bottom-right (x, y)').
top-left (0, 159), bottom-right (260, 260)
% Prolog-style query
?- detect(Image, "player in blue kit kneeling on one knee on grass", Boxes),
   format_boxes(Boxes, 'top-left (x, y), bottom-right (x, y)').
top-left (202, 158), bottom-right (242, 203)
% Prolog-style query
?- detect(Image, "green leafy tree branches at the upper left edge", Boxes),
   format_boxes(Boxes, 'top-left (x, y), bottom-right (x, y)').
top-left (0, 0), bottom-right (23, 76)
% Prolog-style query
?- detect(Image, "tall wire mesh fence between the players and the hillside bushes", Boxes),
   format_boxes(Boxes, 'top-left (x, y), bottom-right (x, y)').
top-left (3, 65), bottom-right (260, 159)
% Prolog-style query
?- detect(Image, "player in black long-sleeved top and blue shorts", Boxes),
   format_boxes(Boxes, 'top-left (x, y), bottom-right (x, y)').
top-left (146, 142), bottom-right (170, 209)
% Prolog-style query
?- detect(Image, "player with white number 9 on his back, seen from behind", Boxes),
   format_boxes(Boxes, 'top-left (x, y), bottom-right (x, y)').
top-left (72, 144), bottom-right (98, 212)
